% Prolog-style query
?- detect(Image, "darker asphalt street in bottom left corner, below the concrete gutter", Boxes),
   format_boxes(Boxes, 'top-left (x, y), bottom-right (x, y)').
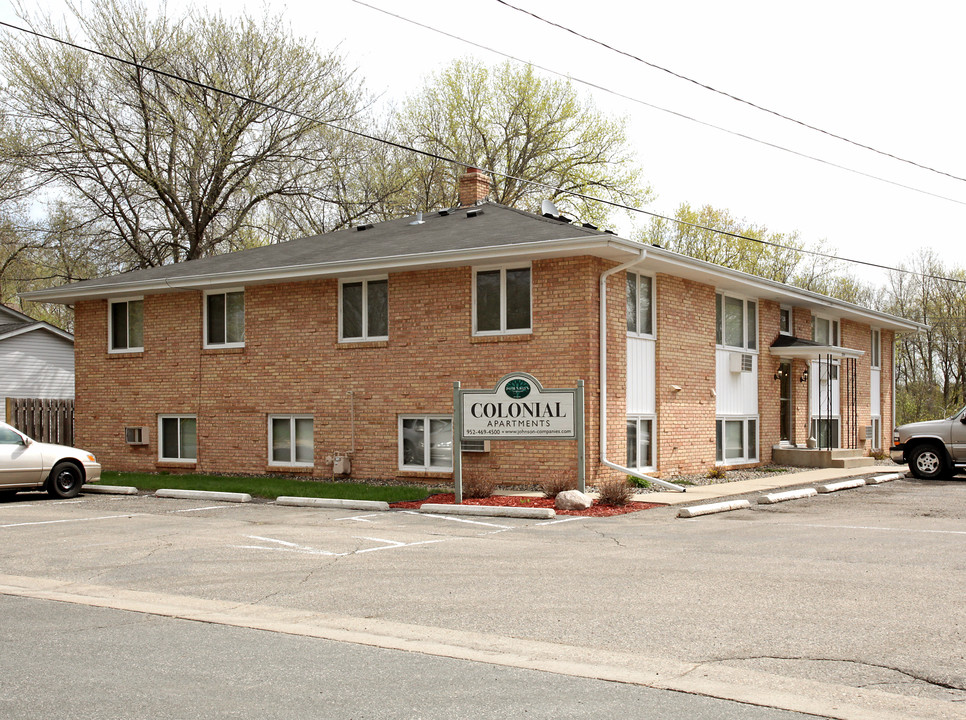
top-left (0, 596), bottom-right (809, 720)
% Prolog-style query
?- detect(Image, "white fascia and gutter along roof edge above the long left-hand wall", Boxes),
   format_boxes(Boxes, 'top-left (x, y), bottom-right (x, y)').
top-left (20, 236), bottom-right (643, 304)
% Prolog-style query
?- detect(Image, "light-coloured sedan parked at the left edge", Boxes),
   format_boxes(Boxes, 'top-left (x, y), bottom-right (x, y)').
top-left (0, 422), bottom-right (101, 498)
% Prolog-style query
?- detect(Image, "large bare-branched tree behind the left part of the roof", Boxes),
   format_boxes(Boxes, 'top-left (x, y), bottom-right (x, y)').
top-left (0, 0), bottom-right (394, 268)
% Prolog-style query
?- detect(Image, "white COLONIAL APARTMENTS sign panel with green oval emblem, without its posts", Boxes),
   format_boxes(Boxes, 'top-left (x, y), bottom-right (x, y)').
top-left (458, 373), bottom-right (580, 440)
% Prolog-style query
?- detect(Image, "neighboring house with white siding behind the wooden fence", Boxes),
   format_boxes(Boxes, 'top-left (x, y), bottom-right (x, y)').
top-left (0, 305), bottom-right (74, 420)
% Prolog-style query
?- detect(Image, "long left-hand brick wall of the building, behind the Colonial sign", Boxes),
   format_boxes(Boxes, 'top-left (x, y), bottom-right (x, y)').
top-left (76, 257), bottom-right (608, 483)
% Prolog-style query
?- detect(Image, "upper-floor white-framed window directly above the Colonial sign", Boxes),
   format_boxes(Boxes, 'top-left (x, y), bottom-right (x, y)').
top-left (473, 265), bottom-right (532, 335)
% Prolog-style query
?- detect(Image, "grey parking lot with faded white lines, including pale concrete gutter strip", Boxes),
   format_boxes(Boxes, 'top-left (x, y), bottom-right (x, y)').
top-left (0, 478), bottom-right (966, 718)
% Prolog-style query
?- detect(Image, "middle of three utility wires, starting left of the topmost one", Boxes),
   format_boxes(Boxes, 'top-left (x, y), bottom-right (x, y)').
top-left (350, 0), bottom-right (966, 205)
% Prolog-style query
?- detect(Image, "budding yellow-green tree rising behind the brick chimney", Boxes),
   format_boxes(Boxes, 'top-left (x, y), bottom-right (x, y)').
top-left (392, 60), bottom-right (650, 224)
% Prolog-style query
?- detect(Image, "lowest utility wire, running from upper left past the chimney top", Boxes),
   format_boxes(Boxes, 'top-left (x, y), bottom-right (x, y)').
top-left (0, 17), bottom-right (966, 285)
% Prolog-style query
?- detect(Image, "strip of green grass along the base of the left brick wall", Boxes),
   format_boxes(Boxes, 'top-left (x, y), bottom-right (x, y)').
top-left (100, 472), bottom-right (435, 502)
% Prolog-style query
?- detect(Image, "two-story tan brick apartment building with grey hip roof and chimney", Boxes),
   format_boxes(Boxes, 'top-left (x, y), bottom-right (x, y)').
top-left (25, 172), bottom-right (921, 484)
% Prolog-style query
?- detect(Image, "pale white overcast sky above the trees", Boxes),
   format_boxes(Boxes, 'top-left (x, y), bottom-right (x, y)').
top-left (0, 0), bottom-right (966, 282)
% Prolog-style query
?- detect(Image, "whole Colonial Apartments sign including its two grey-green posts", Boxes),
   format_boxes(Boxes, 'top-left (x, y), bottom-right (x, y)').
top-left (453, 372), bottom-right (586, 503)
